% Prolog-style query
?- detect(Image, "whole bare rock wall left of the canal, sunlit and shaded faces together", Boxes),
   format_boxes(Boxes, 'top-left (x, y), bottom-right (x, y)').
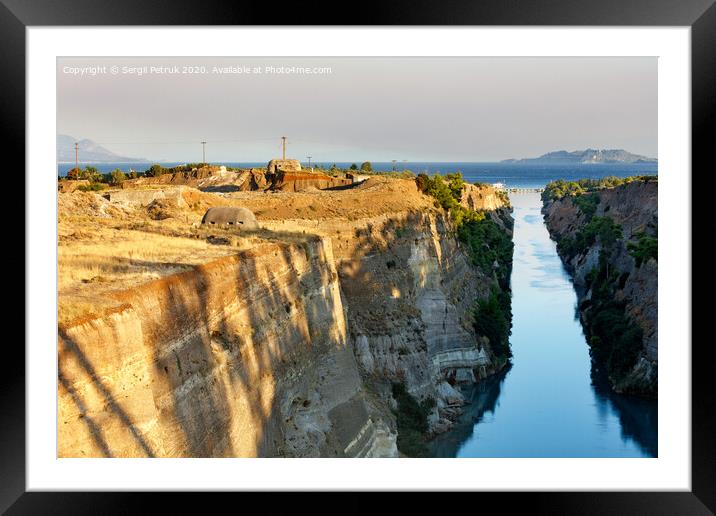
top-left (58, 177), bottom-right (509, 457)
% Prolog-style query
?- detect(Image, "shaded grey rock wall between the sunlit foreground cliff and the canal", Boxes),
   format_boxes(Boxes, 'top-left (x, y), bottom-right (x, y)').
top-left (262, 185), bottom-right (510, 432)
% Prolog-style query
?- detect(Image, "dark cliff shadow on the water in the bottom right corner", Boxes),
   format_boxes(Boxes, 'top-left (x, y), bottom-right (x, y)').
top-left (590, 360), bottom-right (659, 457)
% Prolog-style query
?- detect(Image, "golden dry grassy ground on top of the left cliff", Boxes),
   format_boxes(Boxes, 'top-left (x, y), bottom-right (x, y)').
top-left (57, 179), bottom-right (429, 323)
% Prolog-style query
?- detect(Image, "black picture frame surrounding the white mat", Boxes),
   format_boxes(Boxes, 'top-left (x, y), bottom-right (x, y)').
top-left (0, 0), bottom-right (716, 514)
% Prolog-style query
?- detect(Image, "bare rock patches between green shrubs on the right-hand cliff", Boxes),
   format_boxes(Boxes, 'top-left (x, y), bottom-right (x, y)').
top-left (542, 181), bottom-right (658, 396)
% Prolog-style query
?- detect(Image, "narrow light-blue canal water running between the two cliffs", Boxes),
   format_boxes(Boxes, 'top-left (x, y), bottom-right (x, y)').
top-left (430, 193), bottom-right (658, 457)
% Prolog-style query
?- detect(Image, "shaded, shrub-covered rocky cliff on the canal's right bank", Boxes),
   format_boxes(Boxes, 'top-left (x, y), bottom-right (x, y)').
top-left (542, 179), bottom-right (658, 396)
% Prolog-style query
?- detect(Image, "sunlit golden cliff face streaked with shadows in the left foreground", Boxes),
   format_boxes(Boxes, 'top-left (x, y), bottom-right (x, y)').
top-left (58, 237), bottom-right (397, 457)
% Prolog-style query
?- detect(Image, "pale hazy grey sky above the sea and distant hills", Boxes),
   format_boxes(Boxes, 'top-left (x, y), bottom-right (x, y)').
top-left (57, 57), bottom-right (657, 162)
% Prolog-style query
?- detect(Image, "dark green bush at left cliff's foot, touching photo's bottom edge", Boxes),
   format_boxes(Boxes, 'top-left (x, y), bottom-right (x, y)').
top-left (393, 383), bottom-right (435, 457)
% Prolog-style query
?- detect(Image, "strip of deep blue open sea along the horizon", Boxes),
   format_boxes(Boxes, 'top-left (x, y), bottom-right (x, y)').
top-left (57, 162), bottom-right (657, 188)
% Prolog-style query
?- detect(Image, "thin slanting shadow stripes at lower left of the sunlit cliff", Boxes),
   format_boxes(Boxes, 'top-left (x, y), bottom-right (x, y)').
top-left (58, 329), bottom-right (155, 457)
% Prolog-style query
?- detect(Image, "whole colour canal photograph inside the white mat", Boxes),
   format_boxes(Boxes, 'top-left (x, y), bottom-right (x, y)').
top-left (57, 54), bottom-right (660, 464)
